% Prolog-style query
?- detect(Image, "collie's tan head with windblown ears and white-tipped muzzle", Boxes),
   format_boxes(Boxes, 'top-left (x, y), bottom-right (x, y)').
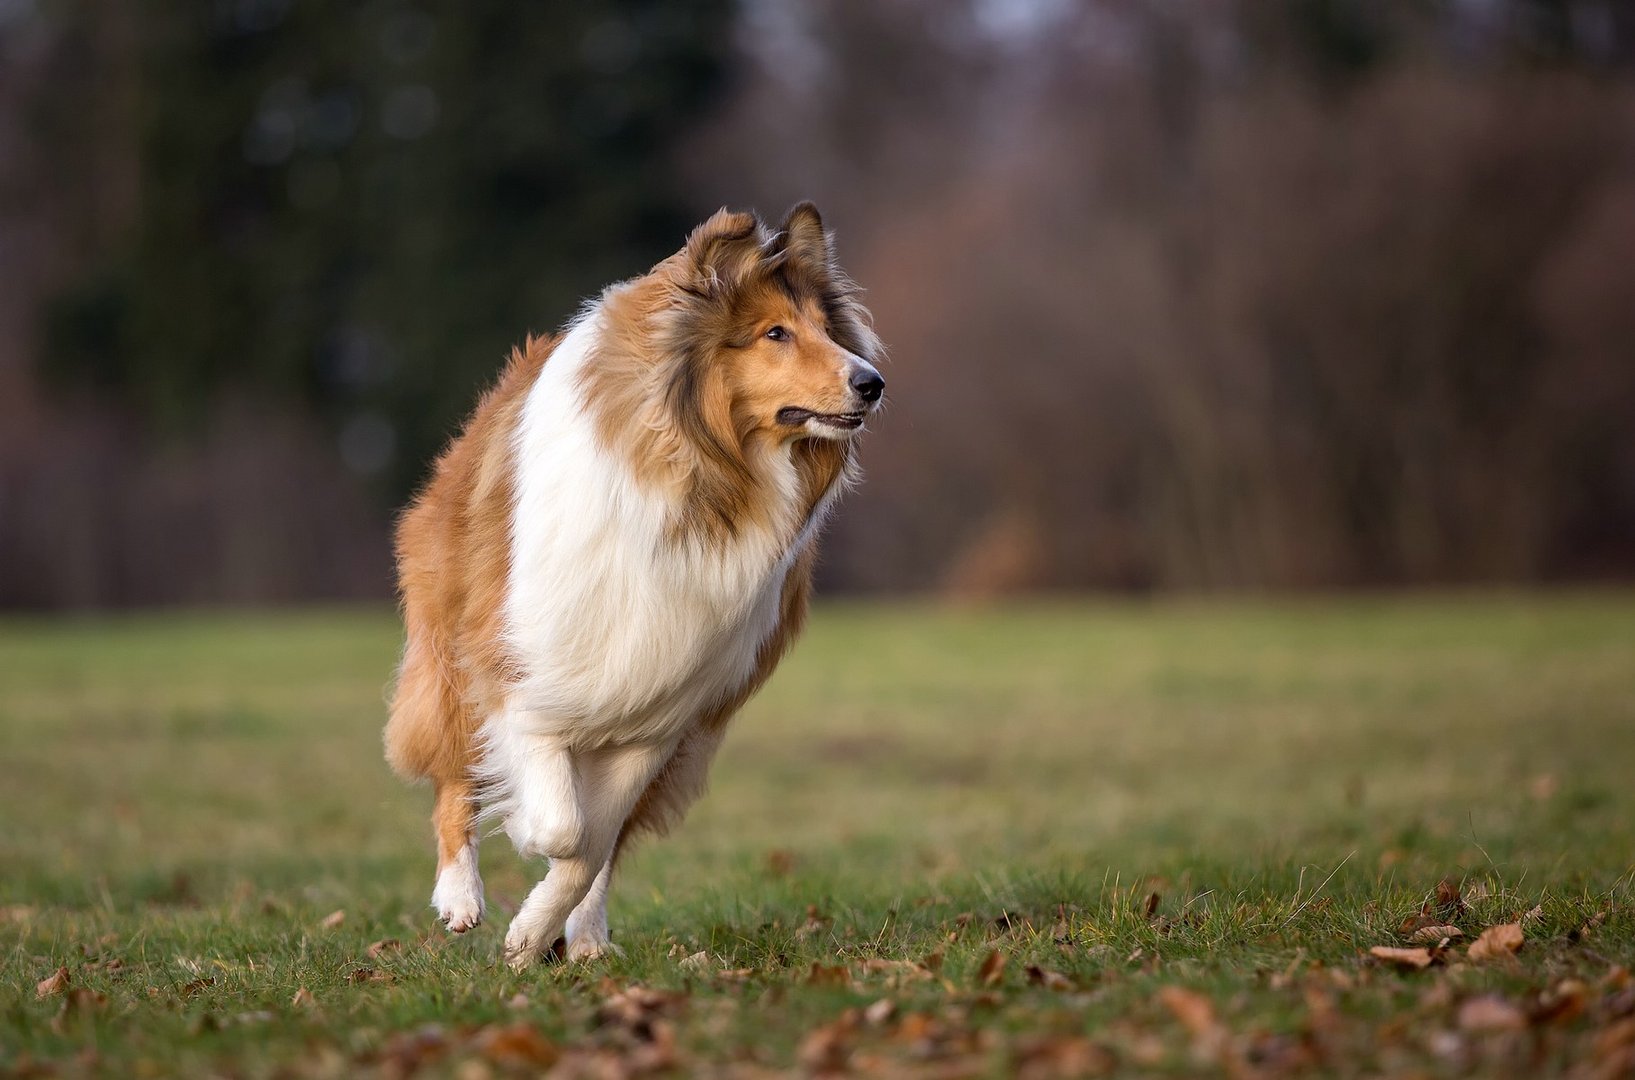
top-left (656, 203), bottom-right (886, 444)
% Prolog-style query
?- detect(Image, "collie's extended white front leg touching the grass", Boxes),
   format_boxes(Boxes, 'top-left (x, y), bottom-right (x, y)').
top-left (505, 743), bottom-right (672, 969)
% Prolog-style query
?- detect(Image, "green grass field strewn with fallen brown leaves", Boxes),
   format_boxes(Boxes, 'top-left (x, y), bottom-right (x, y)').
top-left (0, 595), bottom-right (1635, 1078)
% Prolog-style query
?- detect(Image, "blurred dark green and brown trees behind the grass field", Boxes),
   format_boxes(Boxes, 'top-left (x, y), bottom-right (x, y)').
top-left (0, 0), bottom-right (1635, 609)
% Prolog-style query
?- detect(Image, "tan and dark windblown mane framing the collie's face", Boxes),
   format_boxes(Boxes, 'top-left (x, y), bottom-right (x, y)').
top-left (582, 206), bottom-right (883, 544)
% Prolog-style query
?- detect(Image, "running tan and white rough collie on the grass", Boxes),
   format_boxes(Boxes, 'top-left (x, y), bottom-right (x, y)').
top-left (386, 204), bottom-right (885, 966)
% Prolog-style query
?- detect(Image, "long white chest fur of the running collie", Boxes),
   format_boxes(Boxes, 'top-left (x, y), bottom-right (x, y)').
top-left (505, 312), bottom-right (811, 747)
